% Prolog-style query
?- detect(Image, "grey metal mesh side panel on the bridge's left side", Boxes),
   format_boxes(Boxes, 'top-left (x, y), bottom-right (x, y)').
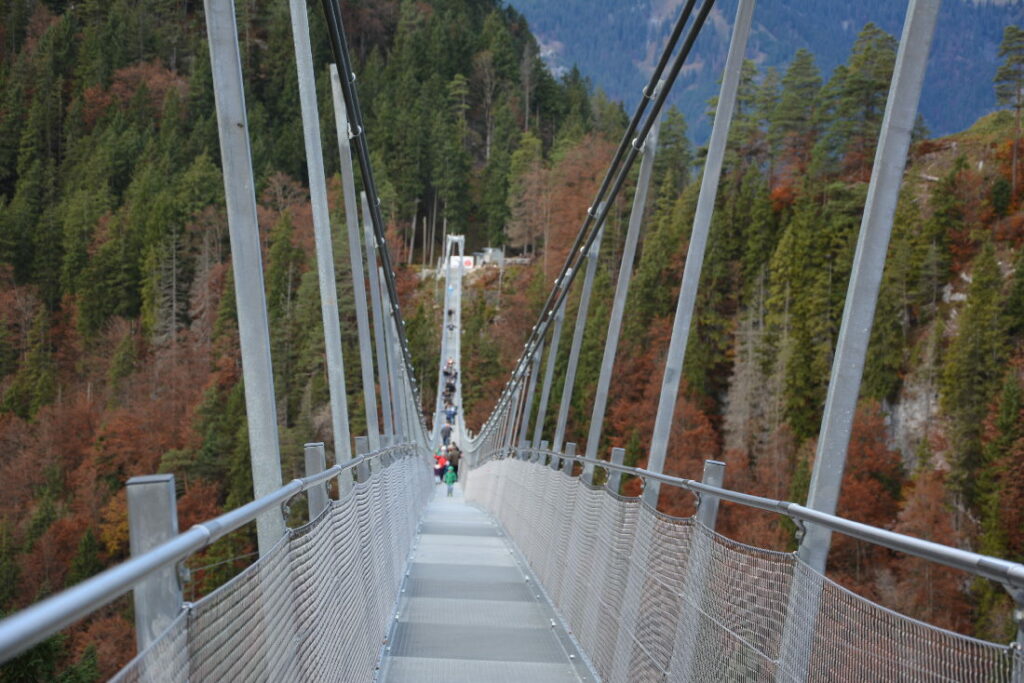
top-left (113, 447), bottom-right (432, 682)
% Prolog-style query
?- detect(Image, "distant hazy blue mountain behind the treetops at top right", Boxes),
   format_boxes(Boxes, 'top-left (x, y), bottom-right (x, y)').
top-left (509, 0), bottom-right (1024, 141)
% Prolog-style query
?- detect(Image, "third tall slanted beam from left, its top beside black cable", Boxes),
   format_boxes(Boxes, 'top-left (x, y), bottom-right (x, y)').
top-left (331, 65), bottom-right (380, 454)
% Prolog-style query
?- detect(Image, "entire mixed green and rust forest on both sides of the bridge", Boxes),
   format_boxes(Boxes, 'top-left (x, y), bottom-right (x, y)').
top-left (0, 0), bottom-right (1024, 681)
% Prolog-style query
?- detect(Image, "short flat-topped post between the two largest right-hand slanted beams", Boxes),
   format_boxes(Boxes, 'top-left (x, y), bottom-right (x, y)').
top-left (669, 460), bottom-right (725, 681)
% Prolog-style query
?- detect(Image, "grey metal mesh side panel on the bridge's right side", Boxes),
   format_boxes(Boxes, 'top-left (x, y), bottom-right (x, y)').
top-left (466, 459), bottom-right (1024, 681)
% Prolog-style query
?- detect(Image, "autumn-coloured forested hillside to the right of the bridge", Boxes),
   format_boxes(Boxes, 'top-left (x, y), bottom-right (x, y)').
top-left (464, 25), bottom-right (1024, 641)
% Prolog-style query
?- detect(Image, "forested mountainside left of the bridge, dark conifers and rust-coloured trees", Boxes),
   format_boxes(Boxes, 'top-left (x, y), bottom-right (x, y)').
top-left (0, 0), bottom-right (593, 680)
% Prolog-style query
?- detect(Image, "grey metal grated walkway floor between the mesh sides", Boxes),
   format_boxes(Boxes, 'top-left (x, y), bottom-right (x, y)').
top-left (381, 484), bottom-right (594, 683)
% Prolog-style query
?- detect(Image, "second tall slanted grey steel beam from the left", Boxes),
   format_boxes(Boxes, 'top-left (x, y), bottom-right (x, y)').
top-left (289, 0), bottom-right (352, 485)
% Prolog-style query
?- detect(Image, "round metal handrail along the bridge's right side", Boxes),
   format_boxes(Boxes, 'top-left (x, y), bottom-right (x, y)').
top-left (476, 447), bottom-right (1024, 593)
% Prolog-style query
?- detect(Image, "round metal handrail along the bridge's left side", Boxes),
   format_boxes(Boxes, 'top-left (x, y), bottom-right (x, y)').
top-left (0, 443), bottom-right (416, 661)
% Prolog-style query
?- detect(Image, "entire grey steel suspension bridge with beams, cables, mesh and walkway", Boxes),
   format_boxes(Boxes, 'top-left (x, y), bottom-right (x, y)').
top-left (0, 0), bottom-right (1024, 682)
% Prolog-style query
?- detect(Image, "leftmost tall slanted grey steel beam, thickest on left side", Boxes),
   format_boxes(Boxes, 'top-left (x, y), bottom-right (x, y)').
top-left (203, 0), bottom-right (285, 555)
